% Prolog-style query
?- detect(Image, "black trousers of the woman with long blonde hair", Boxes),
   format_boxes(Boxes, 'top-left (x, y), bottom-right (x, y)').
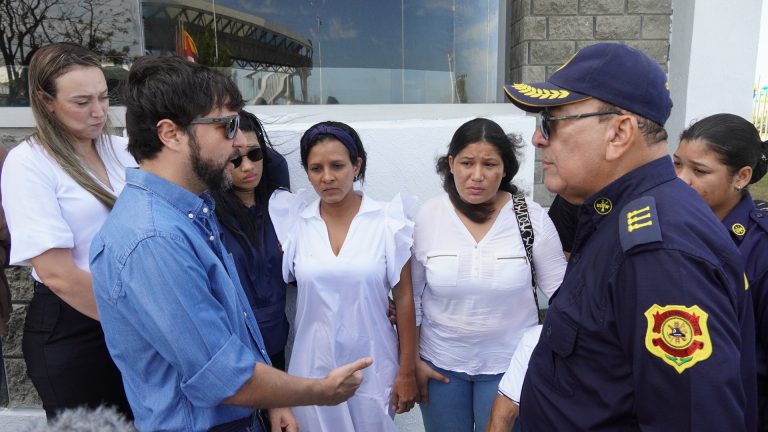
top-left (22, 282), bottom-right (133, 420)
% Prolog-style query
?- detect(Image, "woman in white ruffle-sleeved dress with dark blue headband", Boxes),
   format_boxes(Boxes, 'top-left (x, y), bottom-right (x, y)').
top-left (269, 122), bottom-right (418, 432)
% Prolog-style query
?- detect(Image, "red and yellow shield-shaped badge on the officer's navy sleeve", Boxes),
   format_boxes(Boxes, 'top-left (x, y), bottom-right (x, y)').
top-left (645, 305), bottom-right (712, 373)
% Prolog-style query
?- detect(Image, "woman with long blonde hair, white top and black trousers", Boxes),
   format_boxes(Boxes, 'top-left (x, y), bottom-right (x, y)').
top-left (2, 43), bottom-right (136, 420)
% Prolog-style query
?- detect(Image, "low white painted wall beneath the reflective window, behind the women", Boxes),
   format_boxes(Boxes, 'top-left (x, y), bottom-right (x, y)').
top-left (0, 104), bottom-right (535, 206)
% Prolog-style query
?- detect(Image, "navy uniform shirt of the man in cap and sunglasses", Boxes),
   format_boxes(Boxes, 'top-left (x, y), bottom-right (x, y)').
top-left (520, 157), bottom-right (756, 432)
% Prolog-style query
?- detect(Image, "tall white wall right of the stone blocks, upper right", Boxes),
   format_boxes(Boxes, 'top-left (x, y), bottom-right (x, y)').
top-left (666, 0), bottom-right (762, 150)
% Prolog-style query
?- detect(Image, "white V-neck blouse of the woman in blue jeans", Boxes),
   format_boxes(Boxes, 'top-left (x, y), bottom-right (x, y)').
top-left (411, 194), bottom-right (566, 375)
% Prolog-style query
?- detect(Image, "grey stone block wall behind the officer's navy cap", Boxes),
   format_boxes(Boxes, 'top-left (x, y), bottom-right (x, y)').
top-left (507, 0), bottom-right (672, 206)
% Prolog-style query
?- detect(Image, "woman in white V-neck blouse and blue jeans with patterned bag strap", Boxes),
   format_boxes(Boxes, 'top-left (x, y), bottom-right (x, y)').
top-left (412, 118), bottom-right (566, 432)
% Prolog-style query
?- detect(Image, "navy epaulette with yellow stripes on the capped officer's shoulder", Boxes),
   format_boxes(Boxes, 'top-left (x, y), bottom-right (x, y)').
top-left (619, 196), bottom-right (661, 252)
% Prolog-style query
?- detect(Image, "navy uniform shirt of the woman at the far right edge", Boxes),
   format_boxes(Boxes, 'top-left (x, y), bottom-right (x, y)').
top-left (723, 193), bottom-right (768, 430)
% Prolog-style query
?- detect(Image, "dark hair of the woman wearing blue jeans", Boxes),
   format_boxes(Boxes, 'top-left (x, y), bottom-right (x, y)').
top-left (436, 118), bottom-right (523, 223)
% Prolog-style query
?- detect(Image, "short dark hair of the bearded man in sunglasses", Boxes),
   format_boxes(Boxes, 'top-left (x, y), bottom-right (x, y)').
top-left (123, 56), bottom-right (244, 162)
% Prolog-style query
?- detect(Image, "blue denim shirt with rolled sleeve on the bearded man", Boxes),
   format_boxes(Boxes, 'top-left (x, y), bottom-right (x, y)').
top-left (90, 169), bottom-right (269, 431)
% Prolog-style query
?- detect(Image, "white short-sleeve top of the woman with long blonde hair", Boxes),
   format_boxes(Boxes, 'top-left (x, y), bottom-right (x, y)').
top-left (1, 136), bottom-right (136, 281)
